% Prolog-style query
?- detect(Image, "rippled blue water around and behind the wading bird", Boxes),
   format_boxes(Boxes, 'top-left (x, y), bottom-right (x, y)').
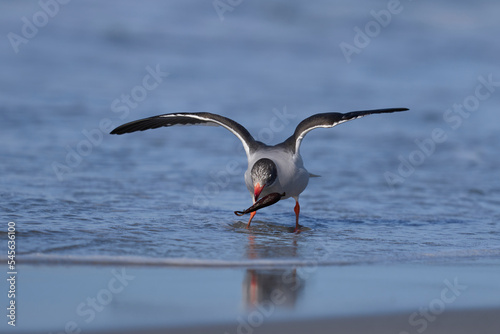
top-left (0, 1), bottom-right (500, 264)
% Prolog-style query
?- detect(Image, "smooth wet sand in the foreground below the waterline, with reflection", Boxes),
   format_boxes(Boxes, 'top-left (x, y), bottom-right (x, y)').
top-left (4, 259), bottom-right (500, 333)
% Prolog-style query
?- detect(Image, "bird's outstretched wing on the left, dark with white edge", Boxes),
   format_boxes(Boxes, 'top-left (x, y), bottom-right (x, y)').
top-left (110, 112), bottom-right (258, 155)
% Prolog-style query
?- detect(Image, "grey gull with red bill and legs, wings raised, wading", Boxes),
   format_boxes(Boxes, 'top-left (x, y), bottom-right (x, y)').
top-left (111, 108), bottom-right (408, 232)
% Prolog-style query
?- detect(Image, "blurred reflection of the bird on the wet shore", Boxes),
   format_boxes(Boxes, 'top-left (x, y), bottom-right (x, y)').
top-left (243, 235), bottom-right (305, 309)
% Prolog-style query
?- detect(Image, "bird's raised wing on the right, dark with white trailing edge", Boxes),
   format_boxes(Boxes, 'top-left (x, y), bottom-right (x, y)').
top-left (284, 108), bottom-right (409, 153)
